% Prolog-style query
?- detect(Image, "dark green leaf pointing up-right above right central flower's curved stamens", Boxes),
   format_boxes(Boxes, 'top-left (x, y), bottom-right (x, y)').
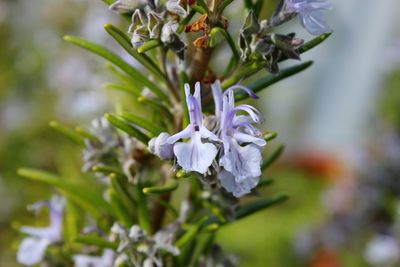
top-left (235, 61), bottom-right (314, 101)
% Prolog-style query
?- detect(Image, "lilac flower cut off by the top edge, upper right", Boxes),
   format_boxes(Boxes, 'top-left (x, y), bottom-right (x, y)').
top-left (285, 0), bottom-right (332, 35)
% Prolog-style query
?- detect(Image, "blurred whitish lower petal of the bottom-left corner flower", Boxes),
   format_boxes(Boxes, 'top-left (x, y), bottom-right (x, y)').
top-left (17, 237), bottom-right (50, 266)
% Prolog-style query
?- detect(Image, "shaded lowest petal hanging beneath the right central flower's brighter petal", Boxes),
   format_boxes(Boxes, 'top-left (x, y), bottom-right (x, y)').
top-left (218, 169), bottom-right (260, 198)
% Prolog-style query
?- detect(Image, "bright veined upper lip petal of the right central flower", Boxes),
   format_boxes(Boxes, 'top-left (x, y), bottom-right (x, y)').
top-left (219, 138), bottom-right (262, 182)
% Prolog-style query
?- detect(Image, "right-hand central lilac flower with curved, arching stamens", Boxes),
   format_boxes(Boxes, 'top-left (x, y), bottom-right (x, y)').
top-left (212, 84), bottom-right (266, 197)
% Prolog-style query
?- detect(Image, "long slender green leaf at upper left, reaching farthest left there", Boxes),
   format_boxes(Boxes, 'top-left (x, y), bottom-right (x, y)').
top-left (64, 36), bottom-right (169, 102)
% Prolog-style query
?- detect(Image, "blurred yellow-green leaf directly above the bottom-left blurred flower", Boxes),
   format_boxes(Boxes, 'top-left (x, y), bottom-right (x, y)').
top-left (18, 168), bottom-right (114, 217)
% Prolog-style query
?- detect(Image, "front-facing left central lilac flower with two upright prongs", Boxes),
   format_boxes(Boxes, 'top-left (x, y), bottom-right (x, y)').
top-left (167, 82), bottom-right (219, 174)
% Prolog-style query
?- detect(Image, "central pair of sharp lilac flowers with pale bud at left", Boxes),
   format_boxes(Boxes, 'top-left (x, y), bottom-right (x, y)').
top-left (149, 80), bottom-right (266, 197)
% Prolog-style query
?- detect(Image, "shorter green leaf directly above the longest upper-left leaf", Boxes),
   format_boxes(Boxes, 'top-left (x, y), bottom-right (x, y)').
top-left (104, 24), bottom-right (165, 79)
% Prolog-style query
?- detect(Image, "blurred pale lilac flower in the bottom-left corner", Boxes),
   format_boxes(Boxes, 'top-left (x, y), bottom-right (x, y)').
top-left (17, 197), bottom-right (65, 266)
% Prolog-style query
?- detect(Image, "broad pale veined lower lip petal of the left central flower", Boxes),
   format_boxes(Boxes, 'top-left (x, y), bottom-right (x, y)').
top-left (174, 132), bottom-right (218, 174)
